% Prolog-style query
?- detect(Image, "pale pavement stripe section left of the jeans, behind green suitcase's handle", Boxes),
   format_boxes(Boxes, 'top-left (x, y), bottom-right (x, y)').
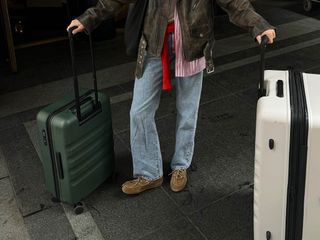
top-left (0, 62), bottom-right (135, 118)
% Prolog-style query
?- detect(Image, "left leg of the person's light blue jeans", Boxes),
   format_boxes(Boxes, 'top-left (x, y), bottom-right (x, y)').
top-left (130, 53), bottom-right (163, 181)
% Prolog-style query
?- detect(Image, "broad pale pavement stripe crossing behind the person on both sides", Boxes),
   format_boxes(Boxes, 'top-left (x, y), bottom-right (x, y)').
top-left (0, 18), bottom-right (320, 118)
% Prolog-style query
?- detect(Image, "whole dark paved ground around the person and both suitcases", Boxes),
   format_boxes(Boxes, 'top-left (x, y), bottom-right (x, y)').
top-left (0, 1), bottom-right (320, 240)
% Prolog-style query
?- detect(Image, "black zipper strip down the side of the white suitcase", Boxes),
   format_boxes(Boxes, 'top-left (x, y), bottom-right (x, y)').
top-left (286, 71), bottom-right (309, 240)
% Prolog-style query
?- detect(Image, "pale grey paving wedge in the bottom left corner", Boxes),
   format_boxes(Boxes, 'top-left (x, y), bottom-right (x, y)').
top-left (0, 178), bottom-right (31, 240)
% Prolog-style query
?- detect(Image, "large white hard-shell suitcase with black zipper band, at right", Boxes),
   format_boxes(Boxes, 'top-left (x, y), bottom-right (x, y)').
top-left (254, 36), bottom-right (320, 240)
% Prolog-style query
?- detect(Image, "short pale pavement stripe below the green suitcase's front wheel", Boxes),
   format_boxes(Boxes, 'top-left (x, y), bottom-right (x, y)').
top-left (61, 203), bottom-right (104, 240)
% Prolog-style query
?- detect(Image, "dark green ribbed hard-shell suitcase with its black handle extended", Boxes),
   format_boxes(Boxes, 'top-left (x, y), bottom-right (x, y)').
top-left (37, 29), bottom-right (114, 212)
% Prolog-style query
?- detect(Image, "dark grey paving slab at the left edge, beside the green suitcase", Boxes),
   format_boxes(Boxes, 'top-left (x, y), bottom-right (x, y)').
top-left (2, 130), bottom-right (54, 216)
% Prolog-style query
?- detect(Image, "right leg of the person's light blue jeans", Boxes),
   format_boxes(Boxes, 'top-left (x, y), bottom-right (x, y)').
top-left (171, 72), bottom-right (203, 171)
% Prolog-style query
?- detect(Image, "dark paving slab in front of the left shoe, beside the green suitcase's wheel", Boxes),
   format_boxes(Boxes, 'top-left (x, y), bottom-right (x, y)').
top-left (86, 186), bottom-right (183, 240)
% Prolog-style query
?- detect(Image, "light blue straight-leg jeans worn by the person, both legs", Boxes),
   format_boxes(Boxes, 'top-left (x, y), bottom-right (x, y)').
top-left (130, 34), bottom-right (203, 180)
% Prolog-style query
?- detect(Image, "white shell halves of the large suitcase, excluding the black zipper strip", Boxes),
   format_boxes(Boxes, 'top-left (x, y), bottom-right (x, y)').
top-left (254, 71), bottom-right (320, 240)
